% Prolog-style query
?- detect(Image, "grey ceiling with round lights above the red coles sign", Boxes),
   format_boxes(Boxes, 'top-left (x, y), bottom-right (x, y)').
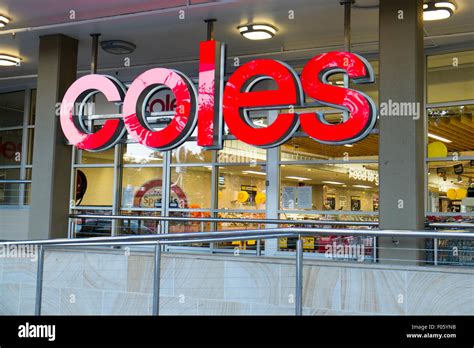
top-left (0, 0), bottom-right (474, 90)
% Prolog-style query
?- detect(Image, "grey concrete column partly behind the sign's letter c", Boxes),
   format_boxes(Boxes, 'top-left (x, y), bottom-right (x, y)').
top-left (28, 34), bottom-right (78, 239)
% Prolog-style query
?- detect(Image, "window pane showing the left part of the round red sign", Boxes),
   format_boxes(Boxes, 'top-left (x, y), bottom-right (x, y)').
top-left (122, 167), bottom-right (163, 209)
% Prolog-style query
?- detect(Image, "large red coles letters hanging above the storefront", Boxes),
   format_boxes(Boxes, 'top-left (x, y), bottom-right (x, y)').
top-left (60, 40), bottom-right (376, 151)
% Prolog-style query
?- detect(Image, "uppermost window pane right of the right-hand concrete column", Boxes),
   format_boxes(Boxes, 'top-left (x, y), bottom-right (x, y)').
top-left (426, 50), bottom-right (474, 103)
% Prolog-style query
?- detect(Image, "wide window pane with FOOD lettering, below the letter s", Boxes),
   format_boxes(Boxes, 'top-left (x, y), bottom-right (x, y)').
top-left (280, 163), bottom-right (379, 213)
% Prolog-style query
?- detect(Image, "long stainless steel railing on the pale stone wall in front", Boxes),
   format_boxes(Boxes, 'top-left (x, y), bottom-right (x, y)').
top-left (0, 228), bottom-right (474, 315)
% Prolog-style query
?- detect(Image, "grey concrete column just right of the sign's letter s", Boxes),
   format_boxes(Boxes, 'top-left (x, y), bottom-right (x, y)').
top-left (379, 0), bottom-right (425, 264)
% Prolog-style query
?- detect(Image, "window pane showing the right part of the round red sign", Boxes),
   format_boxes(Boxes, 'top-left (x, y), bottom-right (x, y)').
top-left (170, 166), bottom-right (212, 209)
